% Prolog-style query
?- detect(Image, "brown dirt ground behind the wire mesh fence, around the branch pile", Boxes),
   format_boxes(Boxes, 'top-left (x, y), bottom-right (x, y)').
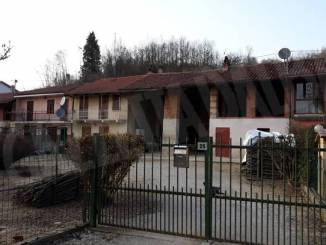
top-left (0, 155), bottom-right (83, 244)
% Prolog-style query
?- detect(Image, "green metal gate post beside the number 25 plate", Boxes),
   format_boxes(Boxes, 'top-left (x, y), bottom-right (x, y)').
top-left (205, 137), bottom-right (213, 240)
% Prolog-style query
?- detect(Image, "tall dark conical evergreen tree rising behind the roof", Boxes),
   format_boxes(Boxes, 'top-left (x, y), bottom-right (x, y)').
top-left (81, 32), bottom-right (101, 81)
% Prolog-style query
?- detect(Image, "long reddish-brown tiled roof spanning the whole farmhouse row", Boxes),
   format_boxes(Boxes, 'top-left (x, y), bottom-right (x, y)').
top-left (17, 58), bottom-right (326, 95)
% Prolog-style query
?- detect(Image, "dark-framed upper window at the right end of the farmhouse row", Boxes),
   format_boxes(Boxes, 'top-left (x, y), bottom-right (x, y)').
top-left (295, 81), bottom-right (323, 114)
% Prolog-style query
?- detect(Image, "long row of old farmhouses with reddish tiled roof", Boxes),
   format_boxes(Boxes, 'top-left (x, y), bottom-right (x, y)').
top-left (1, 58), bottom-right (326, 156)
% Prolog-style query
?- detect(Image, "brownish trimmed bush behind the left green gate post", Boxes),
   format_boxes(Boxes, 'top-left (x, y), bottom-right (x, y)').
top-left (68, 134), bottom-right (144, 199)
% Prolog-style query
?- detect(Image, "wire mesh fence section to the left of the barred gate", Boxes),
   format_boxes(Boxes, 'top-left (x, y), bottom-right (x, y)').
top-left (0, 136), bottom-right (88, 244)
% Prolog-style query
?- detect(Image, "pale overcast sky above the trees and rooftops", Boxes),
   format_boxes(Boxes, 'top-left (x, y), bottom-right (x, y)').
top-left (0, 0), bottom-right (326, 90)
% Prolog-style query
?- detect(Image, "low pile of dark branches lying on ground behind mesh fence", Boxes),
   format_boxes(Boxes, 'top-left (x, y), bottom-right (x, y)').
top-left (15, 171), bottom-right (81, 208)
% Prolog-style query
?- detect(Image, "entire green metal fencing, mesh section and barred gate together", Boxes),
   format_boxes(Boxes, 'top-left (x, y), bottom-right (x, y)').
top-left (0, 134), bottom-right (326, 244)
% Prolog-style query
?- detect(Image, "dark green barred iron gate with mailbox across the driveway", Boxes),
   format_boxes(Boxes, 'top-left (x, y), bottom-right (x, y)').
top-left (90, 138), bottom-right (326, 244)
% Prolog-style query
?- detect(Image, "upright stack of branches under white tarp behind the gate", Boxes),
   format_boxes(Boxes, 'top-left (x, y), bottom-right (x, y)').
top-left (246, 138), bottom-right (294, 179)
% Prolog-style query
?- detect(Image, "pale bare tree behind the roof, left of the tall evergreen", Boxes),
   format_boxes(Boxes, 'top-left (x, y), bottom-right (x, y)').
top-left (41, 50), bottom-right (72, 87)
